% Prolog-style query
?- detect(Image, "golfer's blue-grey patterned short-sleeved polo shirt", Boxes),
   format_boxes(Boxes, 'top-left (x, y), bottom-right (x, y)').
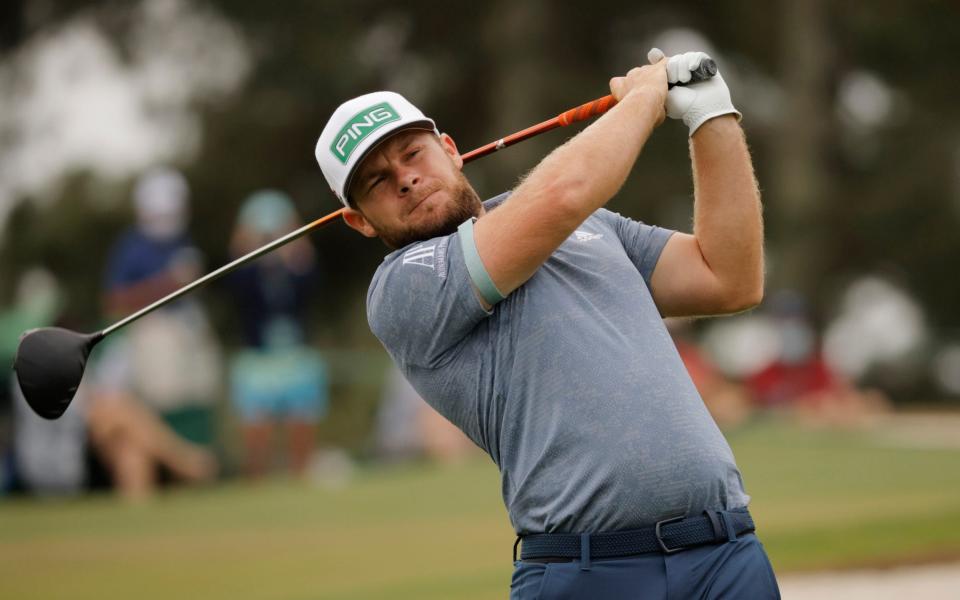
top-left (367, 194), bottom-right (749, 535)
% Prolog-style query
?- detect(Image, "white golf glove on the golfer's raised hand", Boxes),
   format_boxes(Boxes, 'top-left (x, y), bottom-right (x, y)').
top-left (647, 48), bottom-right (742, 135)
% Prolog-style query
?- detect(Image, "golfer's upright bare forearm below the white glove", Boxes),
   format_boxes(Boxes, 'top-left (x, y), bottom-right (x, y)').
top-left (691, 116), bottom-right (763, 306)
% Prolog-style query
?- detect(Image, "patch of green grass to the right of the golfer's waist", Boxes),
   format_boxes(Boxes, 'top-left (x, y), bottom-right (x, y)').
top-left (729, 425), bottom-right (960, 570)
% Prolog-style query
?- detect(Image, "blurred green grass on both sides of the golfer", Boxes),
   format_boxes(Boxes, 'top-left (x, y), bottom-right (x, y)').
top-left (0, 424), bottom-right (960, 600)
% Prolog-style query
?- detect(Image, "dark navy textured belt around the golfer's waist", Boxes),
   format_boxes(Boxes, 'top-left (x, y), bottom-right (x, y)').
top-left (513, 508), bottom-right (754, 561)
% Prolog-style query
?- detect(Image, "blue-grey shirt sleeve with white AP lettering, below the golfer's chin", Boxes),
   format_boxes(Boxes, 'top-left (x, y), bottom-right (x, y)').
top-left (367, 233), bottom-right (492, 368)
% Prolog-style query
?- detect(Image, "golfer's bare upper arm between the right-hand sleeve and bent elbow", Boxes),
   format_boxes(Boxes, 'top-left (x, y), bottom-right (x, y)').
top-left (650, 232), bottom-right (725, 317)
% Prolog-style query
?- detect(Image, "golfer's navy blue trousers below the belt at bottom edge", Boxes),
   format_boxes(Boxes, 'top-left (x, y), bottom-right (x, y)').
top-left (510, 533), bottom-right (780, 600)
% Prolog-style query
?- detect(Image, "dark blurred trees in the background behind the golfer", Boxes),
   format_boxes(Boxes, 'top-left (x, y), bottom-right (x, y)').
top-left (0, 0), bottom-right (960, 418)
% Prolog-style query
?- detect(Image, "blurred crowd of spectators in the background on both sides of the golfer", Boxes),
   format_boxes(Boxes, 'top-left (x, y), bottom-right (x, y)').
top-left (0, 169), bottom-right (889, 501)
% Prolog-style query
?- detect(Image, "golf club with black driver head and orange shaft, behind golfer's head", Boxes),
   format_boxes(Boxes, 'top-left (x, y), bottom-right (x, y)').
top-left (13, 59), bottom-right (717, 419)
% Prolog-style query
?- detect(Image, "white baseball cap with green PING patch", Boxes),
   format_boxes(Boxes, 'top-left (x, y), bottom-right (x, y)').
top-left (316, 92), bottom-right (440, 206)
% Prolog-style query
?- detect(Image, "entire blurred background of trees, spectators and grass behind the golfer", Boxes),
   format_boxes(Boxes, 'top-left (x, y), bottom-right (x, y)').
top-left (0, 0), bottom-right (960, 598)
